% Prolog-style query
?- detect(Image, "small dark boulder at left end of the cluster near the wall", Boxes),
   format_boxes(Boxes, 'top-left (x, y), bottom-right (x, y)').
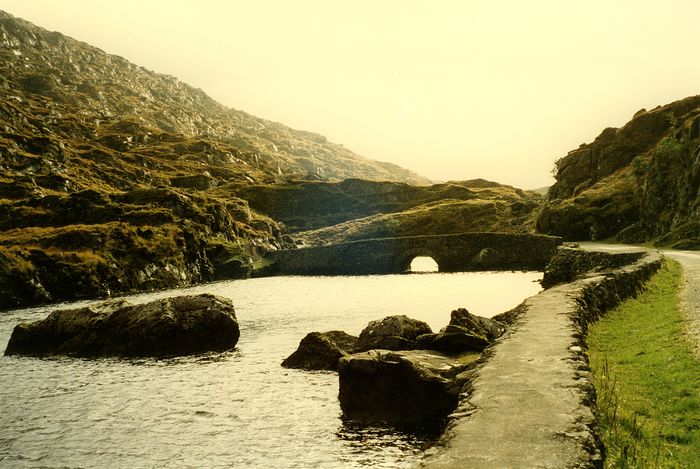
top-left (282, 331), bottom-right (357, 371)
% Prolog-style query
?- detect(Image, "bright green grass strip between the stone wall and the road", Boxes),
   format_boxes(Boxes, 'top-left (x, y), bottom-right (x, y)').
top-left (588, 261), bottom-right (700, 468)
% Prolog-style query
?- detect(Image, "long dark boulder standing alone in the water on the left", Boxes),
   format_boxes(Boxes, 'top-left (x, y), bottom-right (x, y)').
top-left (5, 294), bottom-right (240, 357)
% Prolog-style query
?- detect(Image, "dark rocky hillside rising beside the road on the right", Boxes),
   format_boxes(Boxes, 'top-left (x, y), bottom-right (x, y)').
top-left (537, 96), bottom-right (700, 249)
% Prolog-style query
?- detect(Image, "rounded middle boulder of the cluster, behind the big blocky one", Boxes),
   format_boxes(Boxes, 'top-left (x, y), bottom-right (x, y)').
top-left (355, 315), bottom-right (433, 352)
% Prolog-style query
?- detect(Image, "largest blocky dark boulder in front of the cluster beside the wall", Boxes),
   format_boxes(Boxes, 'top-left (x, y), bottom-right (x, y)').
top-left (338, 350), bottom-right (476, 427)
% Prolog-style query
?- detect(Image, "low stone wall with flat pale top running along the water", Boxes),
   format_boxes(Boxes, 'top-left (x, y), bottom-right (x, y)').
top-left (420, 250), bottom-right (663, 468)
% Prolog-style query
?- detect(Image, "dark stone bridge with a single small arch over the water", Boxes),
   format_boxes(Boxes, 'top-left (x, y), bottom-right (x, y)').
top-left (268, 233), bottom-right (561, 275)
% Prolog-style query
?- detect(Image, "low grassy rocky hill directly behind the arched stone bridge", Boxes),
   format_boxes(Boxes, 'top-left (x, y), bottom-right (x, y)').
top-left (230, 179), bottom-right (542, 244)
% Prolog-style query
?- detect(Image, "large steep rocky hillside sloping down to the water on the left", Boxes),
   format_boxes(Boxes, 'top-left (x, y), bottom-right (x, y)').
top-left (0, 12), bottom-right (427, 308)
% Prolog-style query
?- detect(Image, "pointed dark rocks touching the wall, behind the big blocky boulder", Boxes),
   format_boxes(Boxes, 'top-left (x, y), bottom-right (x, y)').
top-left (418, 308), bottom-right (506, 354)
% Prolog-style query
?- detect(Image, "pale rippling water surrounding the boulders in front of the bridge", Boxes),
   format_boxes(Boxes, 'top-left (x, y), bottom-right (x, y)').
top-left (0, 272), bottom-right (541, 468)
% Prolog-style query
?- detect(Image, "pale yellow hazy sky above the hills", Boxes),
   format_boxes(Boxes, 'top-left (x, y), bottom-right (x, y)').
top-left (0, 0), bottom-right (700, 188)
